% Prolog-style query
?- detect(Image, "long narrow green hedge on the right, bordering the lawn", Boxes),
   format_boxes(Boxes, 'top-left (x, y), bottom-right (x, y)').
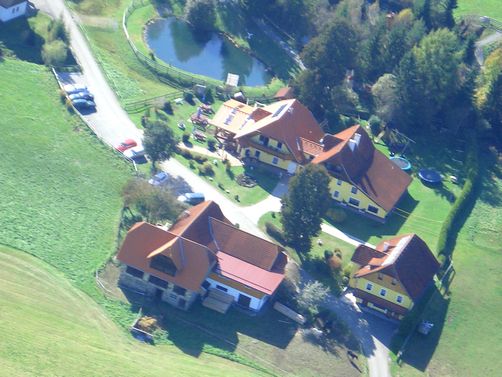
top-left (436, 131), bottom-right (479, 264)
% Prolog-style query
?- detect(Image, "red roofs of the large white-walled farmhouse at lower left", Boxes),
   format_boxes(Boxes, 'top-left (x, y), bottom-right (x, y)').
top-left (117, 201), bottom-right (287, 294)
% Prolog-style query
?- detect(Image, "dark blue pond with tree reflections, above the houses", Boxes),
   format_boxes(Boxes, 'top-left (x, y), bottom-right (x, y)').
top-left (146, 17), bottom-right (272, 86)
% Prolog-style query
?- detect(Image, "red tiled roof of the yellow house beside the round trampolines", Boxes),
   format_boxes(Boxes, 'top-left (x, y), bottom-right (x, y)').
top-left (312, 125), bottom-right (412, 212)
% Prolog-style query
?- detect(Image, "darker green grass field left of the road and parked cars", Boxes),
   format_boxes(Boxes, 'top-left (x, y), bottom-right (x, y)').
top-left (0, 59), bottom-right (131, 288)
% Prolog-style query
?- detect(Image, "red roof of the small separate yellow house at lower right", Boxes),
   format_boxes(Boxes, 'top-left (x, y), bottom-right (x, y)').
top-left (351, 234), bottom-right (439, 300)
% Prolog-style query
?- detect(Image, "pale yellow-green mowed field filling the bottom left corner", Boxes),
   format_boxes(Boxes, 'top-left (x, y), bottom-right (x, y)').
top-left (0, 247), bottom-right (261, 377)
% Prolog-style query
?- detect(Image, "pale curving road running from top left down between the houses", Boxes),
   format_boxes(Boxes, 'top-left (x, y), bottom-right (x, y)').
top-left (31, 0), bottom-right (395, 377)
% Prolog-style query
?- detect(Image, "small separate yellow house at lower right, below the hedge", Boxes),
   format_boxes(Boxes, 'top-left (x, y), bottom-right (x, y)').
top-left (349, 234), bottom-right (439, 319)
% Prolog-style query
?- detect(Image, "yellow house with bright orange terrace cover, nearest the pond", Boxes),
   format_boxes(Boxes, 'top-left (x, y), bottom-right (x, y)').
top-left (209, 99), bottom-right (324, 174)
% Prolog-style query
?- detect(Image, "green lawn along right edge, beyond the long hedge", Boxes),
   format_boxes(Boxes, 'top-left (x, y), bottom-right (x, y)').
top-left (393, 145), bottom-right (502, 377)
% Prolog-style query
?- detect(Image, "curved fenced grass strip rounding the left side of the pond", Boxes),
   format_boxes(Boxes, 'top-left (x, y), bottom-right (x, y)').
top-left (122, 0), bottom-right (223, 90)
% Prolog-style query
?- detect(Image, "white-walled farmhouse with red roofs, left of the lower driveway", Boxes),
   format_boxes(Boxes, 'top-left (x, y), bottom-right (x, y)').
top-left (117, 201), bottom-right (287, 313)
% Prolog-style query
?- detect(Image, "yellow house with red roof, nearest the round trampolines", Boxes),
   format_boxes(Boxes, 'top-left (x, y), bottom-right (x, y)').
top-left (312, 125), bottom-right (412, 221)
